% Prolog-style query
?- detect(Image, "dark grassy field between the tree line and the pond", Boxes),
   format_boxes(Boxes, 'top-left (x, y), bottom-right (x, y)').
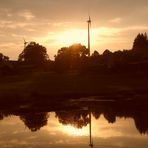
top-left (0, 72), bottom-right (148, 103)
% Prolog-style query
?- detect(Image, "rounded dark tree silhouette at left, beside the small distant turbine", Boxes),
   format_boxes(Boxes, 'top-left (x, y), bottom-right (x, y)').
top-left (18, 42), bottom-right (48, 64)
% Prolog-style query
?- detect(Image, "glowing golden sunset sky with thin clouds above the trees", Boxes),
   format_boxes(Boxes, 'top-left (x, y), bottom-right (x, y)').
top-left (0, 0), bottom-right (148, 60)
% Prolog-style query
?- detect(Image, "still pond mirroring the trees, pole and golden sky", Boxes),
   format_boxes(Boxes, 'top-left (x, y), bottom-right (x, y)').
top-left (0, 97), bottom-right (148, 148)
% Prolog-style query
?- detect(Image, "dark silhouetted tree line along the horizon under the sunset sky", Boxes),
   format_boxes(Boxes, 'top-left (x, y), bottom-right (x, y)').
top-left (0, 33), bottom-right (148, 73)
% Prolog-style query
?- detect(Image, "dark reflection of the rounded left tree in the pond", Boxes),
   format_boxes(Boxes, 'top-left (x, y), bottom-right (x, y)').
top-left (20, 113), bottom-right (48, 132)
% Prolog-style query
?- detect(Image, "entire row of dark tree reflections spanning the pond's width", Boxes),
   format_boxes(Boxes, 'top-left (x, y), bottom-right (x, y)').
top-left (0, 100), bottom-right (148, 134)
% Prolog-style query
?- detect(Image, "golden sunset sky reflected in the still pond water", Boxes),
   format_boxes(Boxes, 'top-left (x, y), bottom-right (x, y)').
top-left (0, 113), bottom-right (148, 148)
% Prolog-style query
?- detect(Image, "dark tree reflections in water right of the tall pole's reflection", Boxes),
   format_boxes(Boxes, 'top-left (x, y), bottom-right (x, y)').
top-left (92, 102), bottom-right (148, 134)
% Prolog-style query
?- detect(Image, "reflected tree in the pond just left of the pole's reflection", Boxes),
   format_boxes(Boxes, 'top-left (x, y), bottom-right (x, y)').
top-left (56, 111), bottom-right (89, 128)
